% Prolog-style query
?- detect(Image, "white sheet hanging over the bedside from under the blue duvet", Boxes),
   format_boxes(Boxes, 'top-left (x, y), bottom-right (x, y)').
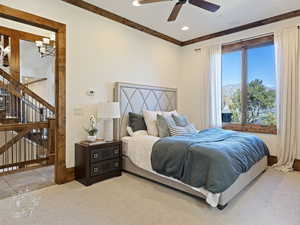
top-left (122, 136), bottom-right (220, 207)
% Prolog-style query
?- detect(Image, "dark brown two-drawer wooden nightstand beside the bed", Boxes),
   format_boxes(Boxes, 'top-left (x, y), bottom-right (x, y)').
top-left (75, 141), bottom-right (122, 186)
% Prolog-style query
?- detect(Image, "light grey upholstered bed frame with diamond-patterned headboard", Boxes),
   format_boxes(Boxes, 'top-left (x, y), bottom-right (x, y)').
top-left (114, 83), bottom-right (268, 210)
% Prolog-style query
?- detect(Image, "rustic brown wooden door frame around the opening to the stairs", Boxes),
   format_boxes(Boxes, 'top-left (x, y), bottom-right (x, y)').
top-left (0, 4), bottom-right (69, 184)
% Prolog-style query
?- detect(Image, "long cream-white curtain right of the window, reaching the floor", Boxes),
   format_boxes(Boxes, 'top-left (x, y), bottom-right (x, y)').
top-left (275, 27), bottom-right (300, 172)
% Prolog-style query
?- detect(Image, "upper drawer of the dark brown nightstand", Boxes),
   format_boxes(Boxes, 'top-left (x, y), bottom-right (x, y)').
top-left (91, 146), bottom-right (120, 163)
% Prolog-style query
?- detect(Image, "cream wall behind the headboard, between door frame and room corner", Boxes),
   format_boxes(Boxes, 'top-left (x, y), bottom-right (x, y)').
top-left (0, 0), bottom-right (181, 167)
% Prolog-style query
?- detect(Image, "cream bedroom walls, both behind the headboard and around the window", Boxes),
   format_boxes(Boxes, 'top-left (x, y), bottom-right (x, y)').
top-left (0, 0), bottom-right (300, 167)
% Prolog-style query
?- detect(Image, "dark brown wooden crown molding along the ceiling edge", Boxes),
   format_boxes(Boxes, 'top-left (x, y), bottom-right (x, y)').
top-left (62, 0), bottom-right (300, 47)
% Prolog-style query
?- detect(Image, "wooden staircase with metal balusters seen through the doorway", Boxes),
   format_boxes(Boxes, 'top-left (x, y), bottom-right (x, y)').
top-left (0, 68), bottom-right (55, 175)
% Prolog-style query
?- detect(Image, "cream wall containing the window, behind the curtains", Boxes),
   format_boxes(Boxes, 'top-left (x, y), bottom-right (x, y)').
top-left (179, 17), bottom-right (300, 158)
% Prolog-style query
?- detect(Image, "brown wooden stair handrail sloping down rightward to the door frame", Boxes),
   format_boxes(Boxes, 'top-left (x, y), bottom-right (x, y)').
top-left (0, 68), bottom-right (55, 113)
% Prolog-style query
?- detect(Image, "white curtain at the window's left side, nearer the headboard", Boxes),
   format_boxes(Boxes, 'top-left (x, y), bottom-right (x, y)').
top-left (199, 44), bottom-right (222, 129)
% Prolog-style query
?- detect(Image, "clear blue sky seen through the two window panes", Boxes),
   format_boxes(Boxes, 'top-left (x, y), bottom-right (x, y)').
top-left (222, 45), bottom-right (276, 87)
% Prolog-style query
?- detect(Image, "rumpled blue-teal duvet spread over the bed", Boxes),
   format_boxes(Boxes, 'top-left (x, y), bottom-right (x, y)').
top-left (151, 129), bottom-right (269, 193)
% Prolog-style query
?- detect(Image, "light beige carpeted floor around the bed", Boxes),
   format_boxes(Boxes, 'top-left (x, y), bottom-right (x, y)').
top-left (0, 169), bottom-right (300, 225)
